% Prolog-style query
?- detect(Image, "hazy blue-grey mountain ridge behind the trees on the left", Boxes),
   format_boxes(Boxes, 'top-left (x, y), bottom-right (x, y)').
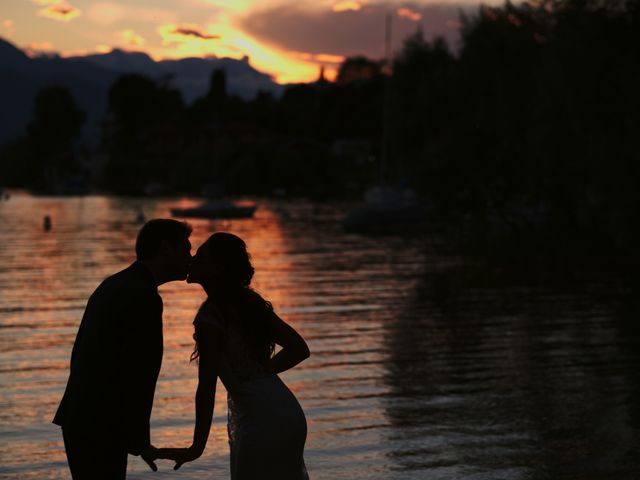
top-left (0, 38), bottom-right (284, 144)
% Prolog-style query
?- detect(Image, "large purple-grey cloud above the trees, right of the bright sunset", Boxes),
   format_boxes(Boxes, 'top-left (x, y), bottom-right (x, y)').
top-left (241, 2), bottom-right (477, 57)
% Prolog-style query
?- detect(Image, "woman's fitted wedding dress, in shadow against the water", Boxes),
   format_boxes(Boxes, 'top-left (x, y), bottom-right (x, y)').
top-left (194, 301), bottom-right (309, 480)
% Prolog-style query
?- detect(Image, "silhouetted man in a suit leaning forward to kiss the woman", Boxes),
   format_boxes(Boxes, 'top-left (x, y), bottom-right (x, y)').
top-left (53, 219), bottom-right (191, 480)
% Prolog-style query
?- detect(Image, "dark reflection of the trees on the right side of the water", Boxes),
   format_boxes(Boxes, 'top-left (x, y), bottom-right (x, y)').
top-left (385, 264), bottom-right (640, 479)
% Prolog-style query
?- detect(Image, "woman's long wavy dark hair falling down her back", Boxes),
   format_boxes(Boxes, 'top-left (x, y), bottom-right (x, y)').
top-left (191, 232), bottom-right (275, 363)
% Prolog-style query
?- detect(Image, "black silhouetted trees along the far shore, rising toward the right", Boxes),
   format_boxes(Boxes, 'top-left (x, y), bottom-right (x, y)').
top-left (0, 0), bottom-right (640, 261)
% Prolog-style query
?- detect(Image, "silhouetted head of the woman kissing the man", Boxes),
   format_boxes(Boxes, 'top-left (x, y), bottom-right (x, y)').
top-left (187, 232), bottom-right (254, 290)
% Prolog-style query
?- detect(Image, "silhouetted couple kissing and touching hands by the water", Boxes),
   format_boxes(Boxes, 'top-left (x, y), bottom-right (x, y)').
top-left (53, 219), bottom-right (309, 480)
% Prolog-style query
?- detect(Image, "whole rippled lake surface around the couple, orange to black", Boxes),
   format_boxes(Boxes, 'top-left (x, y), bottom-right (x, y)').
top-left (0, 195), bottom-right (640, 480)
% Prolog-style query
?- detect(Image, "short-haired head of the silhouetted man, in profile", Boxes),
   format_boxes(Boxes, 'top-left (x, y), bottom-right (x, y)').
top-left (136, 218), bottom-right (192, 284)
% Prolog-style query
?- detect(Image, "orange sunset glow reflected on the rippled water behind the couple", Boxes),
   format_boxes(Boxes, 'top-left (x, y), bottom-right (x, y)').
top-left (0, 196), bottom-right (416, 479)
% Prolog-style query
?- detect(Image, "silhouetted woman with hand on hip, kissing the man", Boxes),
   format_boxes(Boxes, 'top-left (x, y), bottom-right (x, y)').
top-left (159, 233), bottom-right (309, 480)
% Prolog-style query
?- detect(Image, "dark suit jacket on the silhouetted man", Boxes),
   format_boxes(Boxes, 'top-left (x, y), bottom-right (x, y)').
top-left (53, 262), bottom-right (162, 455)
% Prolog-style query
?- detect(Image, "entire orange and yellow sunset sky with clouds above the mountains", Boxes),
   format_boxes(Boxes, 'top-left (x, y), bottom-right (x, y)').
top-left (0, 0), bottom-right (502, 83)
